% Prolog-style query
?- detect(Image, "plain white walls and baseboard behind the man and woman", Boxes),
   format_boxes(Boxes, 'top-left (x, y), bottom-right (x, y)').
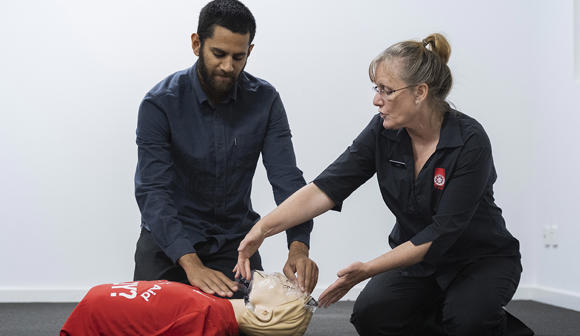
top-left (0, 0), bottom-right (580, 310)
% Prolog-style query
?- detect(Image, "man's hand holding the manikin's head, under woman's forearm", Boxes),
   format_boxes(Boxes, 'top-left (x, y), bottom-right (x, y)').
top-left (284, 241), bottom-right (318, 294)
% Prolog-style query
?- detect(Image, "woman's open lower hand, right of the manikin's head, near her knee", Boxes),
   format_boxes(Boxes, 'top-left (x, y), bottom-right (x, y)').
top-left (318, 261), bottom-right (370, 308)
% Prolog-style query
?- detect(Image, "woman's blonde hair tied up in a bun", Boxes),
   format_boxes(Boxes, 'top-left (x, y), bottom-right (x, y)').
top-left (369, 33), bottom-right (453, 110)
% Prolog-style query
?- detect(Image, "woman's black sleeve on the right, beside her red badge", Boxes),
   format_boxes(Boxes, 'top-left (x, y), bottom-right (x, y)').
top-left (411, 135), bottom-right (493, 265)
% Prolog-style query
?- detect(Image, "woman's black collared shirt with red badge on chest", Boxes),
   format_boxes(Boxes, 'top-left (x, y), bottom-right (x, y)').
top-left (314, 110), bottom-right (520, 288)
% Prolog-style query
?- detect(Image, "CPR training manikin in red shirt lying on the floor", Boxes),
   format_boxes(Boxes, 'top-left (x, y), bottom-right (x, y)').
top-left (60, 272), bottom-right (316, 336)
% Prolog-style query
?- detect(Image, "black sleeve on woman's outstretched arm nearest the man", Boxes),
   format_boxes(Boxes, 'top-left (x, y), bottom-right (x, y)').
top-left (313, 115), bottom-right (382, 211)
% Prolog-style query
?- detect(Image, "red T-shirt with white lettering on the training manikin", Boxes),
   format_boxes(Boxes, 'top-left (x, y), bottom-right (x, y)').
top-left (60, 280), bottom-right (238, 336)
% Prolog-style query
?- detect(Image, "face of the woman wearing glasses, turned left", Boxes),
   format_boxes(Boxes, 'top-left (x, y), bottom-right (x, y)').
top-left (373, 59), bottom-right (418, 129)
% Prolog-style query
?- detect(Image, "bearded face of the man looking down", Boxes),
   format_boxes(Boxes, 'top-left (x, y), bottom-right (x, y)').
top-left (191, 25), bottom-right (253, 100)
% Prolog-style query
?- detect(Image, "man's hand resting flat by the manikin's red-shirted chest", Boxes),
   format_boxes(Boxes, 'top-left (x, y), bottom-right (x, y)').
top-left (177, 253), bottom-right (238, 297)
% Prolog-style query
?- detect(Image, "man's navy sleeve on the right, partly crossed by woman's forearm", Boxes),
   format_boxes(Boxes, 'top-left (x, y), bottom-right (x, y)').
top-left (262, 94), bottom-right (313, 246)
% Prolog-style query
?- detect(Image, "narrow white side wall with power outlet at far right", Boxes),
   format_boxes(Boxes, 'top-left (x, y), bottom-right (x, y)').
top-left (530, 0), bottom-right (580, 310)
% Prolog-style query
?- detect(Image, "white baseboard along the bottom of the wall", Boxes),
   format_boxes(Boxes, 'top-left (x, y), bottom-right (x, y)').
top-left (0, 285), bottom-right (580, 311)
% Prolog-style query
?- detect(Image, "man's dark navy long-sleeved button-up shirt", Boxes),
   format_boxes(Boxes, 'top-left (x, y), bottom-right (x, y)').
top-left (135, 64), bottom-right (312, 262)
